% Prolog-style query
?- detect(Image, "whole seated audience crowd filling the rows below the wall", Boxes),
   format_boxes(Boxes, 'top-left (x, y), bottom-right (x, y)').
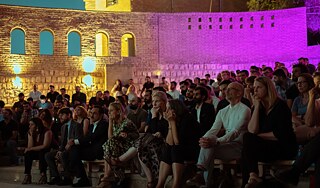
top-left (0, 58), bottom-right (320, 188)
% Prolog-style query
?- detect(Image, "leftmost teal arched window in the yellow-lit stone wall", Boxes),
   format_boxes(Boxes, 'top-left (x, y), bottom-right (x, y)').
top-left (10, 29), bottom-right (26, 54)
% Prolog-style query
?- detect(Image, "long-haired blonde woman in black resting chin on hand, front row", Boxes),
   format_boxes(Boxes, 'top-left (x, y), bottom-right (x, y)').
top-left (242, 77), bottom-right (297, 188)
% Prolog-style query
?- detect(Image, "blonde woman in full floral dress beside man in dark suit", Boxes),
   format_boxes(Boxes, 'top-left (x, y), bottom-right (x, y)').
top-left (98, 102), bottom-right (139, 187)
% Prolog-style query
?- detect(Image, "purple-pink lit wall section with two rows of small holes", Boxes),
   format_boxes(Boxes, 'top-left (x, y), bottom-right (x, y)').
top-left (159, 8), bottom-right (307, 72)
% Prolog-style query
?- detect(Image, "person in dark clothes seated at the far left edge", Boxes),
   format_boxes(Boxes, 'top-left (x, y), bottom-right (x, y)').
top-left (0, 109), bottom-right (18, 165)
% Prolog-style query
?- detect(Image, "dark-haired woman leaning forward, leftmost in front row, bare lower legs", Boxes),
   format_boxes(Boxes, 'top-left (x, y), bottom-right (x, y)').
top-left (22, 118), bottom-right (52, 184)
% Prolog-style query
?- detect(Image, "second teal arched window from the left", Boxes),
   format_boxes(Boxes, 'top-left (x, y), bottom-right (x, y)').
top-left (40, 30), bottom-right (53, 55)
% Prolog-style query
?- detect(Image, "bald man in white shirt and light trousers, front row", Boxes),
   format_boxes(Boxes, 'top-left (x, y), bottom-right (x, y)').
top-left (187, 82), bottom-right (251, 186)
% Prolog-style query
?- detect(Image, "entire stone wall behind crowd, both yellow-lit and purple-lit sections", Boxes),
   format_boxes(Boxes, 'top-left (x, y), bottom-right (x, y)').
top-left (0, 5), bottom-right (320, 105)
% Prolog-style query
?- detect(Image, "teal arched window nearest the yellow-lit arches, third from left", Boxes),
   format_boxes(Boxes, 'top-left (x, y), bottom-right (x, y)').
top-left (68, 31), bottom-right (81, 56)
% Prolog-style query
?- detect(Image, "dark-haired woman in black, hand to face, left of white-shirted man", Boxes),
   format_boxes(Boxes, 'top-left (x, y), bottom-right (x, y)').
top-left (157, 99), bottom-right (201, 188)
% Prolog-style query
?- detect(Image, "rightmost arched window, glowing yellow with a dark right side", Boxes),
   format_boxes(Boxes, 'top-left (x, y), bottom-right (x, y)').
top-left (121, 33), bottom-right (136, 57)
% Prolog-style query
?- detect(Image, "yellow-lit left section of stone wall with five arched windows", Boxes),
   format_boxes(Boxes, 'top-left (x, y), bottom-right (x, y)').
top-left (0, 5), bottom-right (158, 105)
